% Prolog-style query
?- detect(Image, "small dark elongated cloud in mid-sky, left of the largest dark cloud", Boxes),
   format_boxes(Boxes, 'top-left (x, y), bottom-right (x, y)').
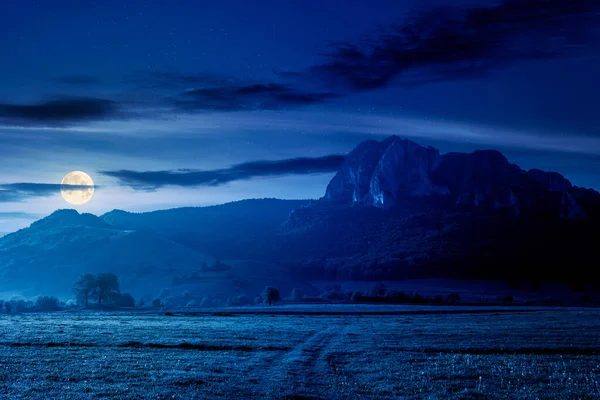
top-left (173, 83), bottom-right (338, 111)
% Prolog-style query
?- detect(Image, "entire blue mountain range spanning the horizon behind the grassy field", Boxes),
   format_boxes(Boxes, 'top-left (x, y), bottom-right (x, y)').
top-left (0, 136), bottom-right (600, 294)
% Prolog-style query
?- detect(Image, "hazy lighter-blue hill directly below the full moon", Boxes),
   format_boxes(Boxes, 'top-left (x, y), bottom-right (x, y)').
top-left (0, 210), bottom-right (213, 295)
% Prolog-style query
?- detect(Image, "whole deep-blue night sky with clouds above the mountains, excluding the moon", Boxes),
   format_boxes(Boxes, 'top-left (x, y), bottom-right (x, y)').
top-left (0, 0), bottom-right (600, 232)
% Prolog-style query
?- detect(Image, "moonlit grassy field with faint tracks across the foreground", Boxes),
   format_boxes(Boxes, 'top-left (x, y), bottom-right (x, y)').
top-left (0, 306), bottom-right (600, 399)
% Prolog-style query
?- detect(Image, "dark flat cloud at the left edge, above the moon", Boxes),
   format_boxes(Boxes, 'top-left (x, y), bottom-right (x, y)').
top-left (0, 97), bottom-right (119, 125)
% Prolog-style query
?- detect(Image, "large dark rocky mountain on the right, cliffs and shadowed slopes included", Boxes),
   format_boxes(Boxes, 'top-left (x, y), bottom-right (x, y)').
top-left (272, 136), bottom-right (600, 280)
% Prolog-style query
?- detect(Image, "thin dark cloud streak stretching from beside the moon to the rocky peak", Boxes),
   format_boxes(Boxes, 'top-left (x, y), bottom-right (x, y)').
top-left (101, 155), bottom-right (345, 190)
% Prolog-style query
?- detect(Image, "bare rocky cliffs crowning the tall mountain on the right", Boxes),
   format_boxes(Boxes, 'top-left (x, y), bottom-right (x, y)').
top-left (323, 136), bottom-right (585, 219)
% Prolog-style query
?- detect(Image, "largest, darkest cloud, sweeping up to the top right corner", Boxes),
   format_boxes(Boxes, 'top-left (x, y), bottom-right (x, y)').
top-left (304, 0), bottom-right (600, 91)
